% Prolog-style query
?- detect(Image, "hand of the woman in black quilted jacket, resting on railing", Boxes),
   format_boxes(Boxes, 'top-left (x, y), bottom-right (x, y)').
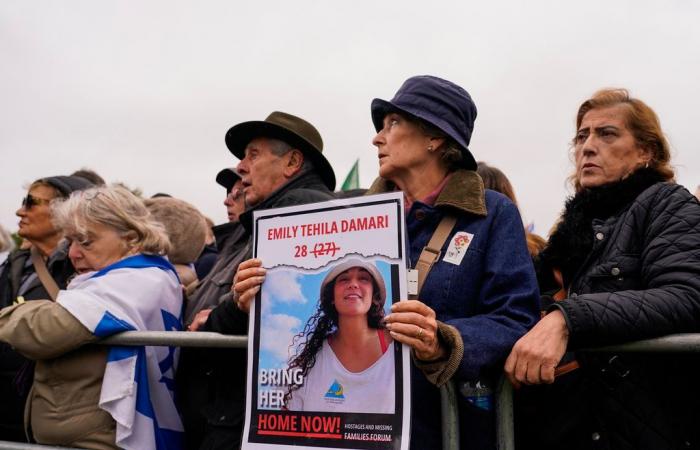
top-left (503, 310), bottom-right (569, 388)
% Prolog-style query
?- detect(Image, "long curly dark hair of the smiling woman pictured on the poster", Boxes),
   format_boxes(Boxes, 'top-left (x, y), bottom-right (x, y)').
top-left (284, 269), bottom-right (385, 407)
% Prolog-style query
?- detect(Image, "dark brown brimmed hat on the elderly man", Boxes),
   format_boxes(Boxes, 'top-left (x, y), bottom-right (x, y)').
top-left (226, 111), bottom-right (335, 191)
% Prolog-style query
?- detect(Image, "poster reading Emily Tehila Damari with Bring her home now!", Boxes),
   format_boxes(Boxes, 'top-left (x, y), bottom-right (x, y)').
top-left (242, 193), bottom-right (411, 450)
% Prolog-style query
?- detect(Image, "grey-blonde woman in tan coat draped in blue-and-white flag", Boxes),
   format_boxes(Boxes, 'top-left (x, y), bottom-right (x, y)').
top-left (0, 187), bottom-right (182, 450)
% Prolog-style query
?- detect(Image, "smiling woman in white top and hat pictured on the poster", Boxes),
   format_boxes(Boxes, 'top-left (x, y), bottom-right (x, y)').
top-left (285, 258), bottom-right (394, 414)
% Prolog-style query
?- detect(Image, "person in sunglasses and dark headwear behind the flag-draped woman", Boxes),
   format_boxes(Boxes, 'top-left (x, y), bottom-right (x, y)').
top-left (0, 176), bottom-right (92, 442)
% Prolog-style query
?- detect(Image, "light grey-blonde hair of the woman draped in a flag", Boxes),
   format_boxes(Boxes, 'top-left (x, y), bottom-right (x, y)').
top-left (51, 186), bottom-right (170, 255)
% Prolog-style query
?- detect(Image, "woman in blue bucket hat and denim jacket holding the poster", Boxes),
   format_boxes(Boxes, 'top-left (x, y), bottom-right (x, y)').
top-left (234, 76), bottom-right (539, 450)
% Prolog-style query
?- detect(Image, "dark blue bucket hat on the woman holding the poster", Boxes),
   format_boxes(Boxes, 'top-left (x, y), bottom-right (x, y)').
top-left (372, 75), bottom-right (476, 170)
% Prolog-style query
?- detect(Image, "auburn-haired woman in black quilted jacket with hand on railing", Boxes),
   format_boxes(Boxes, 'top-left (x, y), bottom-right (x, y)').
top-left (505, 89), bottom-right (700, 450)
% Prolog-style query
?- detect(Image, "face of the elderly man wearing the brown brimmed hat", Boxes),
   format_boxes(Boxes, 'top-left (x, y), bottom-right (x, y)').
top-left (237, 138), bottom-right (293, 208)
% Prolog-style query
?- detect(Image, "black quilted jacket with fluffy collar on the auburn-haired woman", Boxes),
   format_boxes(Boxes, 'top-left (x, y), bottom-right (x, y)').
top-left (516, 169), bottom-right (700, 450)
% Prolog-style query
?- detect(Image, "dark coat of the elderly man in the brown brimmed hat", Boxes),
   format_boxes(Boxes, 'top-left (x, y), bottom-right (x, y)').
top-left (191, 172), bottom-right (333, 450)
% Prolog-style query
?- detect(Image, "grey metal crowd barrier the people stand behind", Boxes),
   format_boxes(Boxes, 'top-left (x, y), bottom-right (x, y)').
top-left (0, 331), bottom-right (700, 450)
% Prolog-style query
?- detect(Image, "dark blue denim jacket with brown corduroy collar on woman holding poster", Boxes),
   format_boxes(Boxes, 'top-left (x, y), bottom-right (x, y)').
top-left (368, 170), bottom-right (539, 449)
